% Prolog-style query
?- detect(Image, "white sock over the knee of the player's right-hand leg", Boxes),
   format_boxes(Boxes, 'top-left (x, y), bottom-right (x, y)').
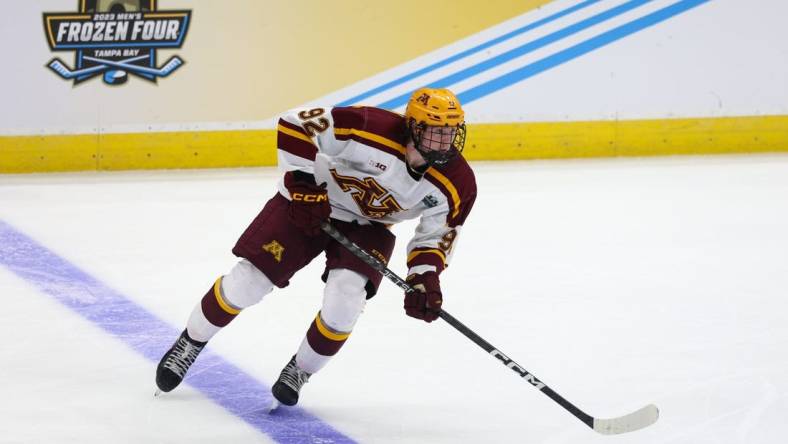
top-left (320, 269), bottom-right (367, 332)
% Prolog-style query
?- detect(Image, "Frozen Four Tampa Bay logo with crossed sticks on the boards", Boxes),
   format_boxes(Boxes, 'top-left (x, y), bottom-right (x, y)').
top-left (44, 0), bottom-right (191, 85)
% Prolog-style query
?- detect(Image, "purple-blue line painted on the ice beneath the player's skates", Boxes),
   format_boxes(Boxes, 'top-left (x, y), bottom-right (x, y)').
top-left (0, 220), bottom-right (354, 444)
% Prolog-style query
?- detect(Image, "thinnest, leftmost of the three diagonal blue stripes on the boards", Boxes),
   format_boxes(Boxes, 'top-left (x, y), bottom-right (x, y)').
top-left (336, 0), bottom-right (602, 106)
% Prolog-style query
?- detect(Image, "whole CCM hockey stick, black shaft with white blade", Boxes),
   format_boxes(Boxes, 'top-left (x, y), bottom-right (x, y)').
top-left (321, 222), bottom-right (659, 435)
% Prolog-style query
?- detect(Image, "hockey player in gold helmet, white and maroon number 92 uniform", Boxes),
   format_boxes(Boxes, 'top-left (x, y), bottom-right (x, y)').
top-left (156, 88), bottom-right (476, 405)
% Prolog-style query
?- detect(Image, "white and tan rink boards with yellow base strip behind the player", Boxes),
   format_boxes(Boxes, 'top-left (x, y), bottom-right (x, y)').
top-left (0, 0), bottom-right (788, 173)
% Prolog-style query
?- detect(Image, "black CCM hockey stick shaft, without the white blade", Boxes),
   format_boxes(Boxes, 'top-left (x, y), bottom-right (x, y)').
top-left (321, 222), bottom-right (594, 428)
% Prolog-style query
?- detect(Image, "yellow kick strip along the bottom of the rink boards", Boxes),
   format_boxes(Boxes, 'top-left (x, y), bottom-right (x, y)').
top-left (0, 116), bottom-right (788, 173)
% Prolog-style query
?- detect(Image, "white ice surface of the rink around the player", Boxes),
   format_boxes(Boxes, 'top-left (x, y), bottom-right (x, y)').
top-left (0, 155), bottom-right (788, 444)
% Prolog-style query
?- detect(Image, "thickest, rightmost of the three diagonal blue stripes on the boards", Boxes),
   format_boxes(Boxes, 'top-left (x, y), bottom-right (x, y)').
top-left (457, 0), bottom-right (709, 104)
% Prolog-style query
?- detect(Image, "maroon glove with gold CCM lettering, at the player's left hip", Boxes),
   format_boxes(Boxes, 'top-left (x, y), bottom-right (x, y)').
top-left (285, 173), bottom-right (331, 236)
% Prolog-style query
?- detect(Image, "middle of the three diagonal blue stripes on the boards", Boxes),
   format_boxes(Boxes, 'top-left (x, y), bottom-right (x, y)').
top-left (378, 0), bottom-right (653, 109)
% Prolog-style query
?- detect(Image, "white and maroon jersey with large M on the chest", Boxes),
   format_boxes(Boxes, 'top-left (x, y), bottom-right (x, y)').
top-left (277, 107), bottom-right (476, 273)
